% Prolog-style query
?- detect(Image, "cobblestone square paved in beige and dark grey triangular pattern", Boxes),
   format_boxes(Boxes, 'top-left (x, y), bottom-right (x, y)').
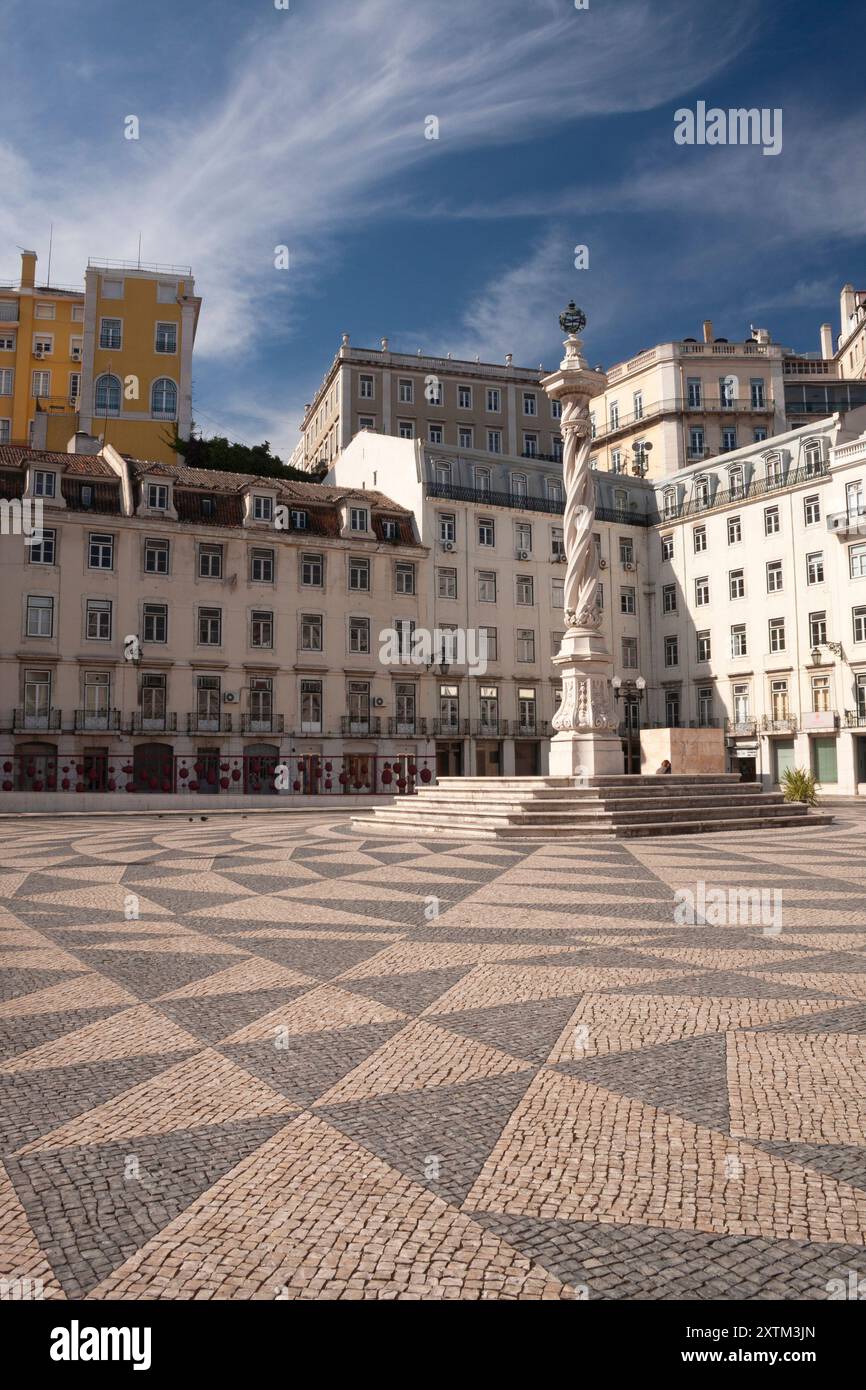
top-left (0, 808), bottom-right (866, 1300)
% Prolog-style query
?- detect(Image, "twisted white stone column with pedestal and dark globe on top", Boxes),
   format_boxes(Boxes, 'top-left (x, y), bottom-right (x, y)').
top-left (541, 308), bottom-right (623, 777)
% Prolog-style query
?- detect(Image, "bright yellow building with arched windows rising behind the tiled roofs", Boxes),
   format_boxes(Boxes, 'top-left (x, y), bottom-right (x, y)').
top-left (0, 252), bottom-right (202, 463)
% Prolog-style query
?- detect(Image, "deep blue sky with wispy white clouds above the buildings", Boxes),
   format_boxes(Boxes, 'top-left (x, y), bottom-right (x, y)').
top-left (0, 0), bottom-right (866, 452)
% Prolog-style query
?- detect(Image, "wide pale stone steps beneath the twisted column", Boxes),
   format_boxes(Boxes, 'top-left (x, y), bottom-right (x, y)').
top-left (352, 773), bottom-right (833, 840)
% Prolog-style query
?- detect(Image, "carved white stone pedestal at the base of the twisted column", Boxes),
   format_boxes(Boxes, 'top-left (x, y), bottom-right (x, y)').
top-left (550, 627), bottom-right (624, 777)
